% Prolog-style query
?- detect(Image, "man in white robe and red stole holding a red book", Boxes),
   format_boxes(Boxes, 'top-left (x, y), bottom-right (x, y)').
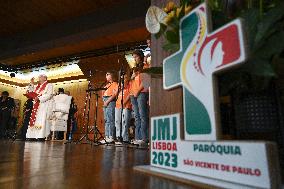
top-left (26, 74), bottom-right (53, 139)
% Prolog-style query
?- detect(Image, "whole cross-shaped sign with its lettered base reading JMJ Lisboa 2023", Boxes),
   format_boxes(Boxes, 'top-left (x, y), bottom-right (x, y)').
top-left (136, 3), bottom-right (280, 188)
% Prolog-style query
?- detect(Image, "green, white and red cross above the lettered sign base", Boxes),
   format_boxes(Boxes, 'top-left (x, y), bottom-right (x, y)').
top-left (163, 4), bottom-right (245, 140)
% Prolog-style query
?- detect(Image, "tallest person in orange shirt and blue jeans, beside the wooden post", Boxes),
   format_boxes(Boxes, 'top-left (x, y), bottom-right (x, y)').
top-left (130, 50), bottom-right (149, 145)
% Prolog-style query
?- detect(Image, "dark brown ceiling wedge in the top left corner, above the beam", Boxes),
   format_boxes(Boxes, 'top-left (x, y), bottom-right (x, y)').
top-left (0, 0), bottom-right (125, 37)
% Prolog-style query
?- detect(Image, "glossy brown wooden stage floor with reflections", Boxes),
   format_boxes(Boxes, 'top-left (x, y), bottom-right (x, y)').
top-left (0, 141), bottom-right (195, 189)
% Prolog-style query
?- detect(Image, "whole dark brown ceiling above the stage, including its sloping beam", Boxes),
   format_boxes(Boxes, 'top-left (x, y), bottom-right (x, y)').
top-left (0, 0), bottom-right (150, 66)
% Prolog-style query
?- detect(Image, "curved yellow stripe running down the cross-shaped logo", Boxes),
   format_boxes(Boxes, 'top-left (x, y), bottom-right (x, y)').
top-left (181, 14), bottom-right (207, 89)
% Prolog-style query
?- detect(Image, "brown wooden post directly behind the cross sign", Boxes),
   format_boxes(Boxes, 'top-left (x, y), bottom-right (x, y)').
top-left (150, 0), bottom-right (183, 117)
